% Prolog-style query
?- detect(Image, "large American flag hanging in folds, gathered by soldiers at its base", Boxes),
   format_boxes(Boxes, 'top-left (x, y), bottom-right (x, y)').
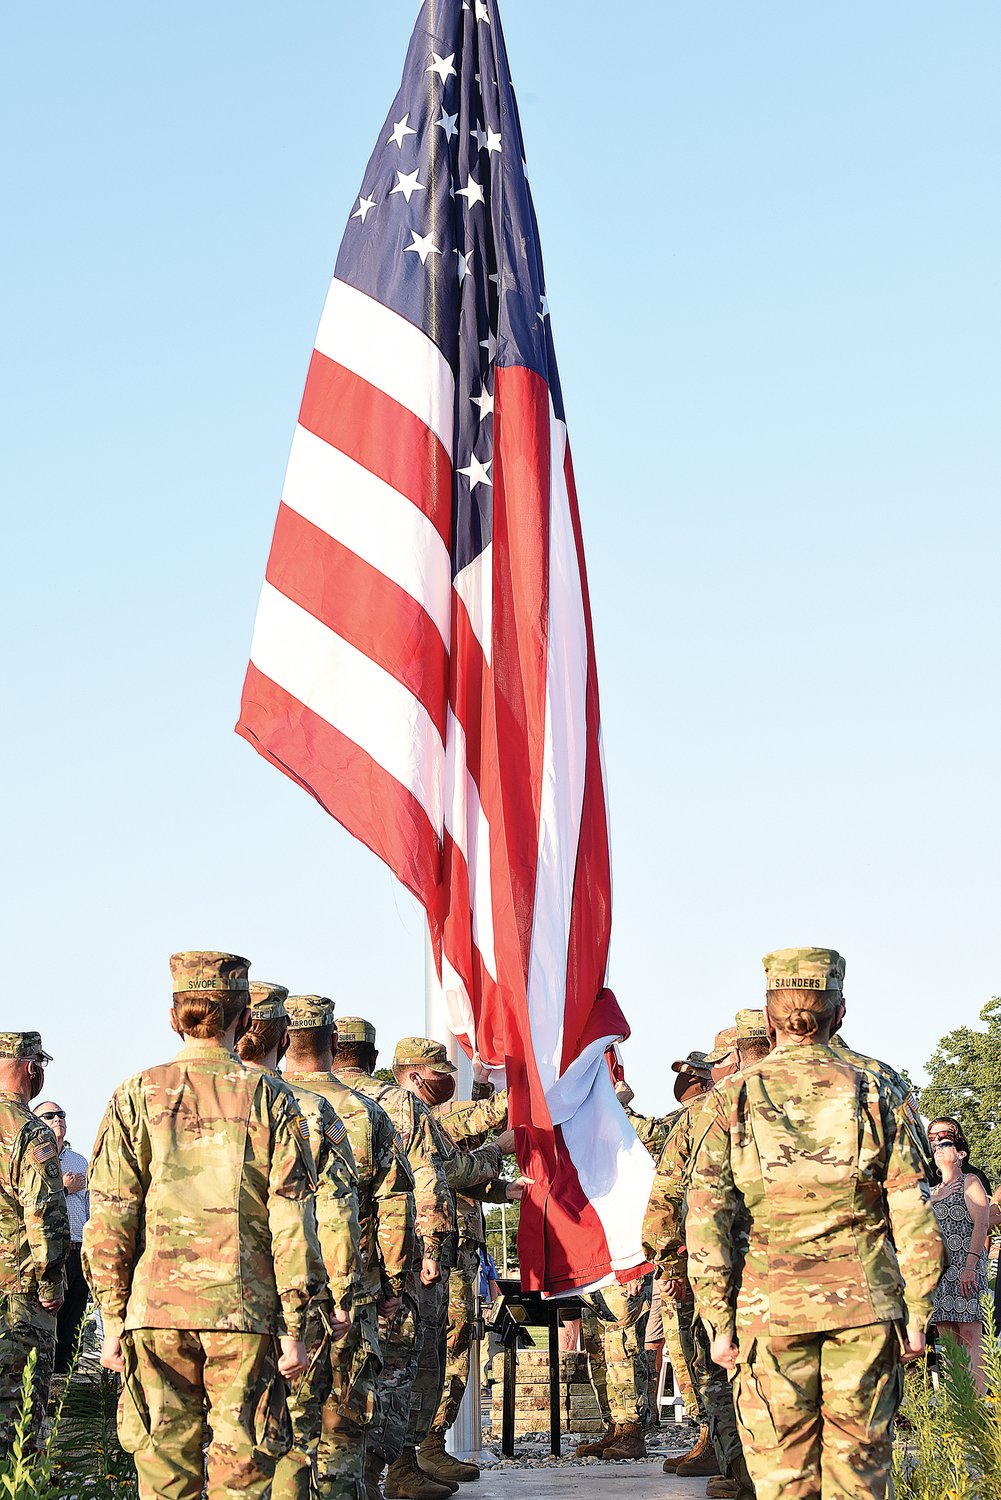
top-left (237, 0), bottom-right (651, 1292)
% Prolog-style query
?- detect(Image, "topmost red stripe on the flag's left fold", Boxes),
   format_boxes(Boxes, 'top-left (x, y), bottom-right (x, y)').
top-left (299, 350), bottom-right (452, 548)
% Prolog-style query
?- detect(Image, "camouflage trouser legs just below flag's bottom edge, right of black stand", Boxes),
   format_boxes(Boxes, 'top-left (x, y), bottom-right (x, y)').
top-left (581, 1277), bottom-right (651, 1425)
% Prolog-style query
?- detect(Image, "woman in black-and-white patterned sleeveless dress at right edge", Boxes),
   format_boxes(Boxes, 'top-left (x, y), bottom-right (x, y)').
top-left (927, 1121), bottom-right (990, 1395)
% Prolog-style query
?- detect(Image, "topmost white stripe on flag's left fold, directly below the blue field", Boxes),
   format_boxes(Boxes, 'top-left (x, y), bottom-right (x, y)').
top-left (317, 276), bottom-right (455, 455)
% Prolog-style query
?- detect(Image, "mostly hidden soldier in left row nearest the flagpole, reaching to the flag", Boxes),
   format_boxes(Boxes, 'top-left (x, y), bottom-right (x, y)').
top-left (419, 1064), bottom-right (524, 1484)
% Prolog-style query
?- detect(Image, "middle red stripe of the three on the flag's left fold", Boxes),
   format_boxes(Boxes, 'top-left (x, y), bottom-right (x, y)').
top-left (267, 503), bottom-right (449, 744)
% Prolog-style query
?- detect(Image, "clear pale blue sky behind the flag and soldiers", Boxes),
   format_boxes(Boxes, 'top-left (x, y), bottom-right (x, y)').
top-left (0, 0), bottom-right (1001, 1149)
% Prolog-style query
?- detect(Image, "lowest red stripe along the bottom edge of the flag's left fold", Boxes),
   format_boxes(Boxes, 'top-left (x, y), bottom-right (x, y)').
top-left (236, 663), bottom-right (441, 906)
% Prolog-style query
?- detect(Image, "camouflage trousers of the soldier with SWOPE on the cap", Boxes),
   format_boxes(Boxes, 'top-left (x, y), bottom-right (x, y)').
top-left (119, 1328), bottom-right (291, 1500)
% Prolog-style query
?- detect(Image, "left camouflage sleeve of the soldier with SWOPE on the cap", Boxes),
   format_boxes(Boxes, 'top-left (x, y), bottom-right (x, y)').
top-left (83, 1085), bottom-right (150, 1338)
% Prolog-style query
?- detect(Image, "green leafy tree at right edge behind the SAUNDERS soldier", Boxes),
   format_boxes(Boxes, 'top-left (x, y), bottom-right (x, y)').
top-left (920, 996), bottom-right (1001, 1187)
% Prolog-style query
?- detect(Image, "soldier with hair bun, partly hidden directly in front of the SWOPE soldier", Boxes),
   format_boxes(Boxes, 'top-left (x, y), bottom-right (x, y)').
top-left (237, 980), bottom-right (362, 1500)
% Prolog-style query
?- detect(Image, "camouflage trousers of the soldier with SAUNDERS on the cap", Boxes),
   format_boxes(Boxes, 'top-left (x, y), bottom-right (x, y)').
top-left (737, 1323), bottom-right (903, 1500)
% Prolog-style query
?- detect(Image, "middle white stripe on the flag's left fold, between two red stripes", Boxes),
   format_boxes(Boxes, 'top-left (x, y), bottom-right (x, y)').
top-left (282, 426), bottom-right (452, 647)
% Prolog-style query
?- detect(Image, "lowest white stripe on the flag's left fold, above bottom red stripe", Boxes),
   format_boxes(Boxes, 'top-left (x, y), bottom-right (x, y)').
top-left (251, 584), bottom-right (444, 834)
